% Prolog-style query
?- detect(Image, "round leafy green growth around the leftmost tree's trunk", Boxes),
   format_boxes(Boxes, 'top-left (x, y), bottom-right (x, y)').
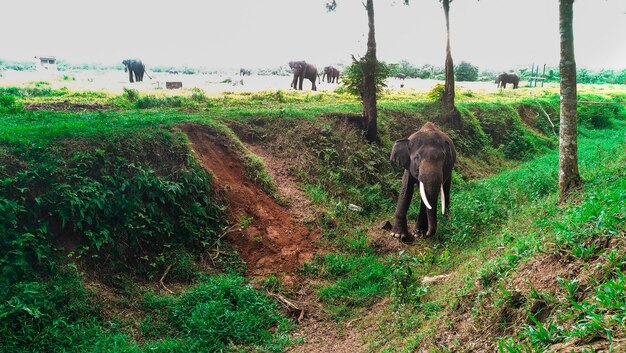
top-left (341, 59), bottom-right (392, 97)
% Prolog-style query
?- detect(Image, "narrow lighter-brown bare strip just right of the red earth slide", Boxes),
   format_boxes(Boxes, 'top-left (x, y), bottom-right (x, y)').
top-left (246, 144), bottom-right (316, 223)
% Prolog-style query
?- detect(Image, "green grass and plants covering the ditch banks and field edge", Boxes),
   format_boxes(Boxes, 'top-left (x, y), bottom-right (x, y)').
top-left (0, 84), bottom-right (624, 352)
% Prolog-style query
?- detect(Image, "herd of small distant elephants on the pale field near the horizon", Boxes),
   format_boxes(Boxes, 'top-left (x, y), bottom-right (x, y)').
top-left (122, 59), bottom-right (519, 91)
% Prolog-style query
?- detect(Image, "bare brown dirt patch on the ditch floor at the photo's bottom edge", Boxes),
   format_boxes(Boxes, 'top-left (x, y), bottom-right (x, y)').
top-left (287, 300), bottom-right (389, 353)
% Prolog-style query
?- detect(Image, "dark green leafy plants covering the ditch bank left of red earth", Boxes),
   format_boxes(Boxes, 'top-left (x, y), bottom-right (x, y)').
top-left (0, 128), bottom-right (221, 281)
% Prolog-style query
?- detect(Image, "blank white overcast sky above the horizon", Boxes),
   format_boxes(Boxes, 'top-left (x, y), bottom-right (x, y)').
top-left (0, 0), bottom-right (626, 70)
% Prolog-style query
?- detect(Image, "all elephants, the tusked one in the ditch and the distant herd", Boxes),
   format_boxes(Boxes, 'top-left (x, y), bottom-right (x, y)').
top-left (122, 59), bottom-right (519, 243)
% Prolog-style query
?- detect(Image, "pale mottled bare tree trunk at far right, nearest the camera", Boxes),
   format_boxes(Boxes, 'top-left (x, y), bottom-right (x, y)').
top-left (559, 0), bottom-right (581, 202)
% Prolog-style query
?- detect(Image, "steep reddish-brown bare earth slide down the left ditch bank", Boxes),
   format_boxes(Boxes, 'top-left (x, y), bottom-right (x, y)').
top-left (180, 124), bottom-right (319, 276)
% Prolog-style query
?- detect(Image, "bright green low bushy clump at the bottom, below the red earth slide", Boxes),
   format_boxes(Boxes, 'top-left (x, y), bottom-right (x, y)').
top-left (140, 275), bottom-right (293, 352)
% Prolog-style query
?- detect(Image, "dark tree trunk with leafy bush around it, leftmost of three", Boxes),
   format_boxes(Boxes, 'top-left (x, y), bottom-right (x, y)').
top-left (361, 0), bottom-right (379, 142)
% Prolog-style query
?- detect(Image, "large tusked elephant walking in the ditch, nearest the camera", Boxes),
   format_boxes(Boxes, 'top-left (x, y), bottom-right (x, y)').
top-left (391, 122), bottom-right (456, 243)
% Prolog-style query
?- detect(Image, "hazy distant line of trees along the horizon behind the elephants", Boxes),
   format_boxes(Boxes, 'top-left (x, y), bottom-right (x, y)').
top-left (0, 60), bottom-right (626, 84)
